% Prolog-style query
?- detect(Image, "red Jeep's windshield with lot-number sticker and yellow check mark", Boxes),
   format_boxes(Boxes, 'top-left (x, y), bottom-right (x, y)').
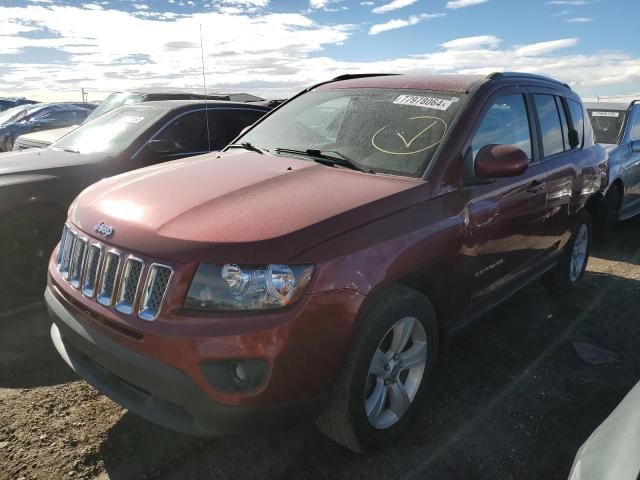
top-left (238, 88), bottom-right (464, 177)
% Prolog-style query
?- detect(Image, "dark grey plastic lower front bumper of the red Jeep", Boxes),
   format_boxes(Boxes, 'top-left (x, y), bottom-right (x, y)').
top-left (45, 286), bottom-right (322, 435)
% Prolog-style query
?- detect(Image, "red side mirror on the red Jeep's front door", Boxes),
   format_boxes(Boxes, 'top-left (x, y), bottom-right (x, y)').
top-left (474, 145), bottom-right (529, 178)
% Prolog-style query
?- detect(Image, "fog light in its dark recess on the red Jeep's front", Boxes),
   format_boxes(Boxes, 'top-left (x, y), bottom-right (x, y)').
top-left (200, 358), bottom-right (268, 393)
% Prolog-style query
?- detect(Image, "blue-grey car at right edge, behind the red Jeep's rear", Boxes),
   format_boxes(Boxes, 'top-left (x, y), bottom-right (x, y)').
top-left (585, 100), bottom-right (640, 240)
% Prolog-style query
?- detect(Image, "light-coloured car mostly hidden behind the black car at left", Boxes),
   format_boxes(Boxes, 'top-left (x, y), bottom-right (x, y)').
top-left (13, 88), bottom-right (268, 150)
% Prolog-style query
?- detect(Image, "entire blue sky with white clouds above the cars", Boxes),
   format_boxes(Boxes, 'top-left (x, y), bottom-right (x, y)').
top-left (0, 0), bottom-right (640, 101)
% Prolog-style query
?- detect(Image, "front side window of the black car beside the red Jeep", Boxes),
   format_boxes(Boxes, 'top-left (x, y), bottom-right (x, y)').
top-left (154, 110), bottom-right (213, 154)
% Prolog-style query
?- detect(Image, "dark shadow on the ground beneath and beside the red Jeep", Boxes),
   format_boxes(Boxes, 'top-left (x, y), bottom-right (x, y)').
top-left (94, 226), bottom-right (640, 480)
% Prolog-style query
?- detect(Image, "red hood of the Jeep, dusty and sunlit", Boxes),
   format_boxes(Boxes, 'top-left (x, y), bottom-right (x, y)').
top-left (70, 152), bottom-right (427, 263)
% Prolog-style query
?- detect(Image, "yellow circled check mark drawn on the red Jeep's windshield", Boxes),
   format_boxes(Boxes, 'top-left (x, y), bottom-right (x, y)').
top-left (371, 116), bottom-right (448, 155)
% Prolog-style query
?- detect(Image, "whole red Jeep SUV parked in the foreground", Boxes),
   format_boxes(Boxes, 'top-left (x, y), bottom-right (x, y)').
top-left (45, 73), bottom-right (608, 451)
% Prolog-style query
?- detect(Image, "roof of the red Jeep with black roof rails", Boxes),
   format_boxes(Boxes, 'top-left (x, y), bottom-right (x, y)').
top-left (318, 72), bottom-right (571, 93)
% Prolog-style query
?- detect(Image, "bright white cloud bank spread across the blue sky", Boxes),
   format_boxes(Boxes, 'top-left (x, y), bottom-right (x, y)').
top-left (0, 0), bottom-right (640, 100)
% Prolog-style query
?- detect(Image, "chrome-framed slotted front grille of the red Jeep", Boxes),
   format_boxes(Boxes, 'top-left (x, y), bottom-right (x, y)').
top-left (56, 225), bottom-right (173, 321)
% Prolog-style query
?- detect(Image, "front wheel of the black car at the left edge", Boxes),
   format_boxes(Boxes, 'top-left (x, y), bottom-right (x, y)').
top-left (0, 206), bottom-right (66, 296)
